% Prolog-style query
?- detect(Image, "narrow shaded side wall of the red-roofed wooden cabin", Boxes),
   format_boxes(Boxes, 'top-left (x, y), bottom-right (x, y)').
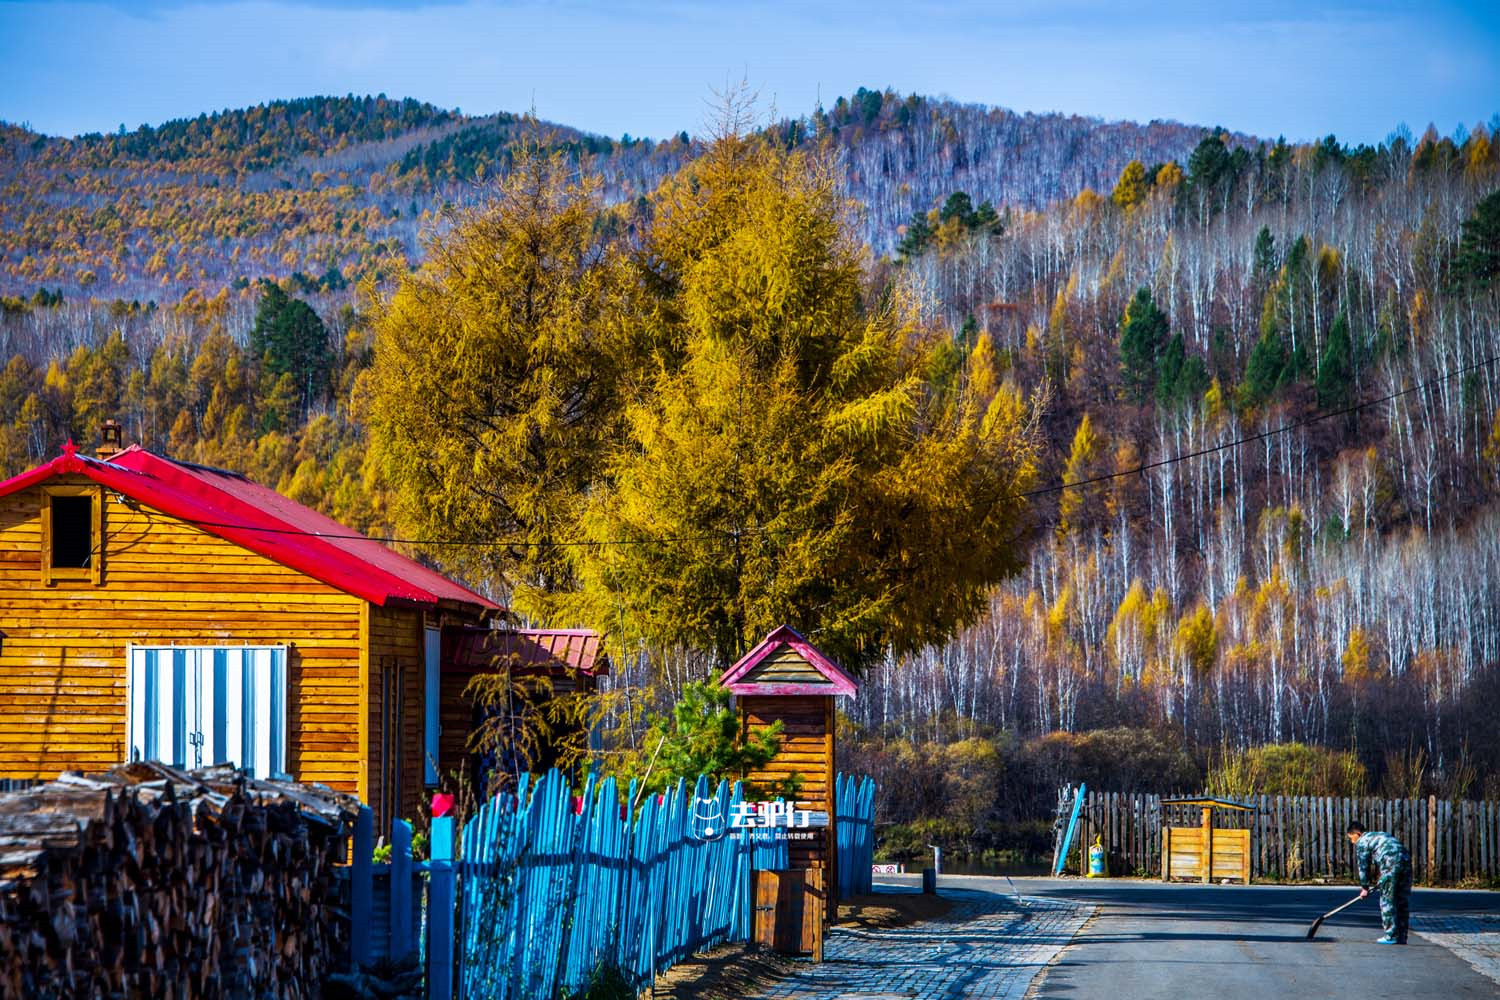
top-left (368, 606), bottom-right (426, 829)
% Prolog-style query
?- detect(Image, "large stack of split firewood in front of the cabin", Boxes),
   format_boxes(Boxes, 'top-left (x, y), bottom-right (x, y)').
top-left (0, 763), bottom-right (359, 1000)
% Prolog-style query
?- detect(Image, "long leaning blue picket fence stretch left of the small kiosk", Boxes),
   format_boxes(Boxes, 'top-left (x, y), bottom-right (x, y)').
top-left (459, 772), bottom-right (786, 1000)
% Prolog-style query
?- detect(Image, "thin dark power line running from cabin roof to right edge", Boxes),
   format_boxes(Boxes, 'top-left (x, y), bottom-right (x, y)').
top-left (155, 354), bottom-right (1500, 549)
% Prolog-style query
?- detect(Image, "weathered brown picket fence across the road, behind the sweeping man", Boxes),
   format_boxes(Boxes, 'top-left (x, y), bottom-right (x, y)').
top-left (1059, 789), bottom-right (1500, 885)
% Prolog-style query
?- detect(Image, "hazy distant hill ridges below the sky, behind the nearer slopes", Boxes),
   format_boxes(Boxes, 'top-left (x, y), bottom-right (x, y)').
top-left (0, 90), bottom-right (1230, 301)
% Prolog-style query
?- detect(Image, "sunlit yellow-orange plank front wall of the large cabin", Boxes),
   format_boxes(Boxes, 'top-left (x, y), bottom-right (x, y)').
top-left (0, 477), bottom-right (363, 793)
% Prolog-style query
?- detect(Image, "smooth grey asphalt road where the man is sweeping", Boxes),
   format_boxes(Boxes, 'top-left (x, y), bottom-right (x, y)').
top-left (876, 876), bottom-right (1500, 1000)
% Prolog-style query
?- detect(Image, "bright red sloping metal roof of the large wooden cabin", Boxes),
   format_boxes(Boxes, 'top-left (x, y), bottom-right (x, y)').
top-left (0, 442), bottom-right (500, 610)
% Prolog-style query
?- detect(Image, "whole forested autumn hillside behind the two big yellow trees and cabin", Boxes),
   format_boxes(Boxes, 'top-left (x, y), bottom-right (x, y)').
top-left (0, 90), bottom-right (1500, 823)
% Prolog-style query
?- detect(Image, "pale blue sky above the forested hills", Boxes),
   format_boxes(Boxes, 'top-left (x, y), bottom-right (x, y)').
top-left (0, 0), bottom-right (1500, 141)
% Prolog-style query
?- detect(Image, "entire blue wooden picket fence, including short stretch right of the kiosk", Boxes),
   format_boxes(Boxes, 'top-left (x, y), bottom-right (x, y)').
top-left (351, 772), bottom-right (875, 1000)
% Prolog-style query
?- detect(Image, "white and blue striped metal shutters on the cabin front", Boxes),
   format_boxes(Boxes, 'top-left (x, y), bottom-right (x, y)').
top-left (126, 646), bottom-right (287, 778)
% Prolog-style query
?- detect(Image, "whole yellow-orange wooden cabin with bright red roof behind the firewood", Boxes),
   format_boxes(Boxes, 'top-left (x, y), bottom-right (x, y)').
top-left (0, 444), bottom-right (500, 829)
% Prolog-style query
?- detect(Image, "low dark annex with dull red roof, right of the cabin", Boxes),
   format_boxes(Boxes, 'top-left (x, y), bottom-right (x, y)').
top-left (438, 627), bottom-right (609, 789)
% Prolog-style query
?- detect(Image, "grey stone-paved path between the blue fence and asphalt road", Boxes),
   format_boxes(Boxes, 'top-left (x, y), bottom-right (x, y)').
top-left (759, 889), bottom-right (1094, 1000)
